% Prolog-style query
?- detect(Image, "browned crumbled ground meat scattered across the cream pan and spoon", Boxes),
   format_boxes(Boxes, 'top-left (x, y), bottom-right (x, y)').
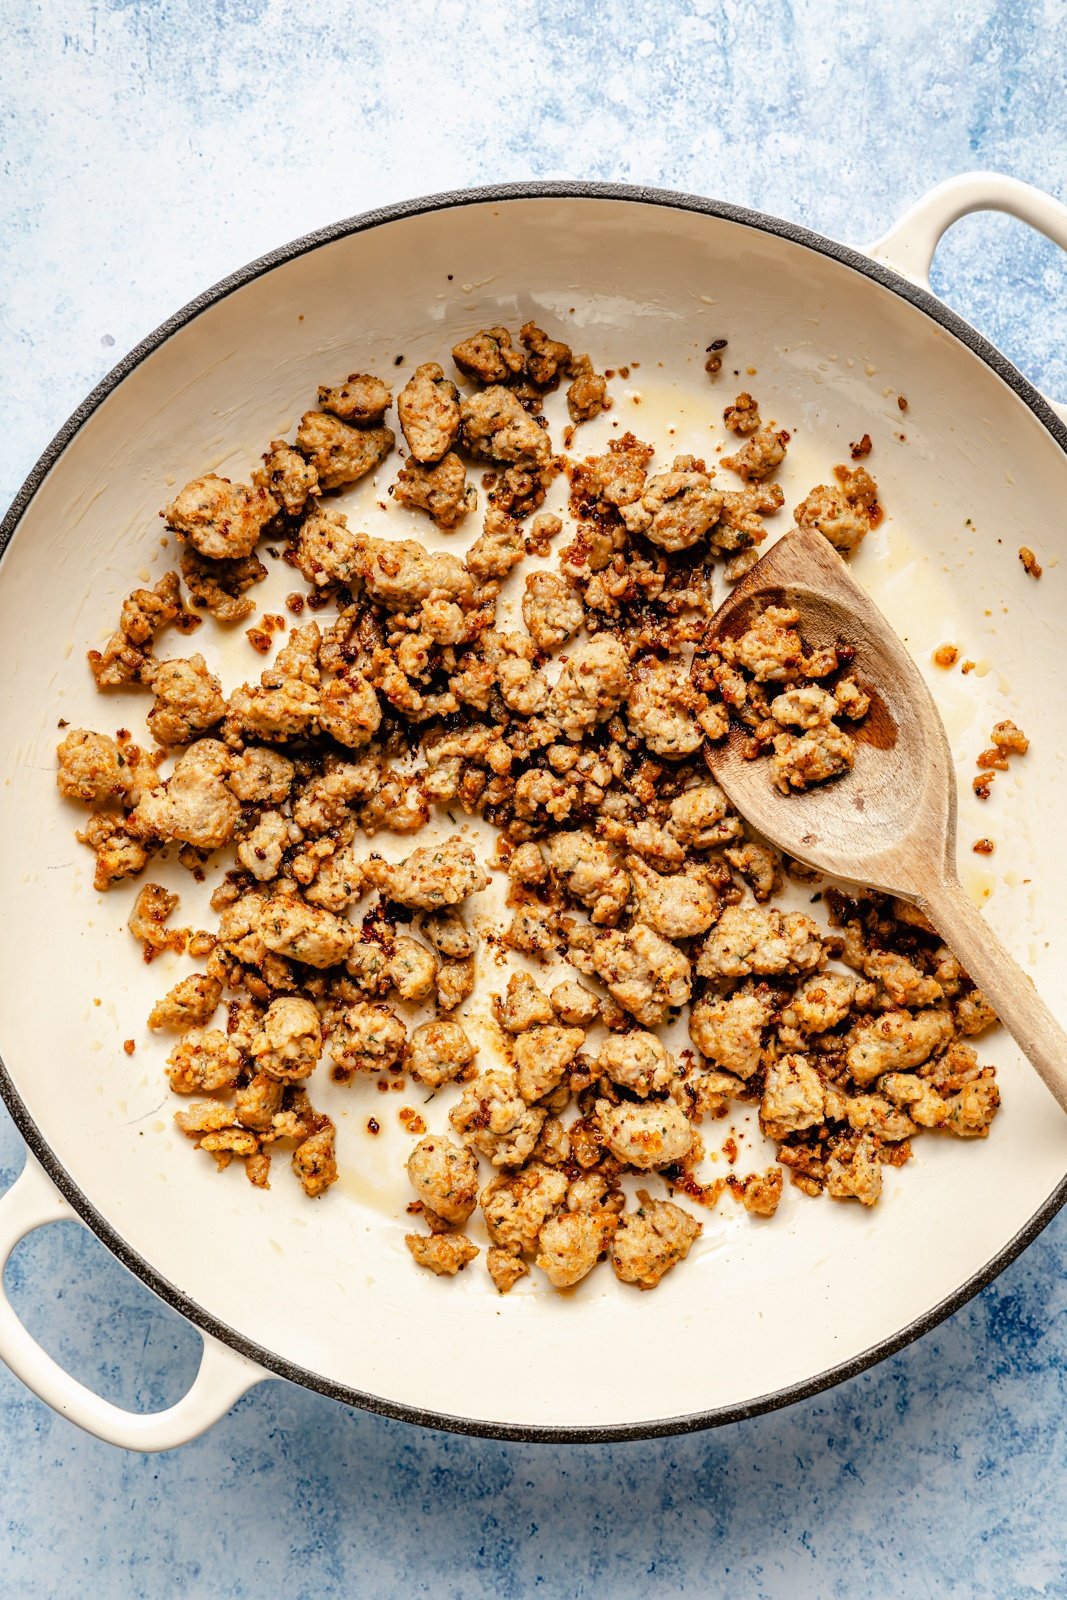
top-left (59, 322), bottom-right (1004, 1293)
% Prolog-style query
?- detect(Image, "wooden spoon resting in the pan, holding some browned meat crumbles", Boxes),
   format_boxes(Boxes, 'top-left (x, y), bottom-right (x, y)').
top-left (696, 528), bottom-right (1067, 1110)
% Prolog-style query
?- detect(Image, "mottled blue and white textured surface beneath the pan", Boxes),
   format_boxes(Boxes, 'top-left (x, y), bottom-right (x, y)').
top-left (0, 0), bottom-right (1067, 1600)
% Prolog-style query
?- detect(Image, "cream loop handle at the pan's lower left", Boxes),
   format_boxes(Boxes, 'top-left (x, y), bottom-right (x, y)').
top-left (0, 1154), bottom-right (269, 1451)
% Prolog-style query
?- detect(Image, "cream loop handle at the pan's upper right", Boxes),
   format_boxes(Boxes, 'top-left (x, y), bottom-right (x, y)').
top-left (867, 173), bottom-right (1067, 422)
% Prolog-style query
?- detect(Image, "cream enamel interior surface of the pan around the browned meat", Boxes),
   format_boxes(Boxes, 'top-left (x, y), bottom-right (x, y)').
top-left (0, 195), bottom-right (1067, 1432)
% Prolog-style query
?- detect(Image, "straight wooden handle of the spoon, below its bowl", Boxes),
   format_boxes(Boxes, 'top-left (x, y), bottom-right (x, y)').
top-left (918, 878), bottom-right (1067, 1110)
